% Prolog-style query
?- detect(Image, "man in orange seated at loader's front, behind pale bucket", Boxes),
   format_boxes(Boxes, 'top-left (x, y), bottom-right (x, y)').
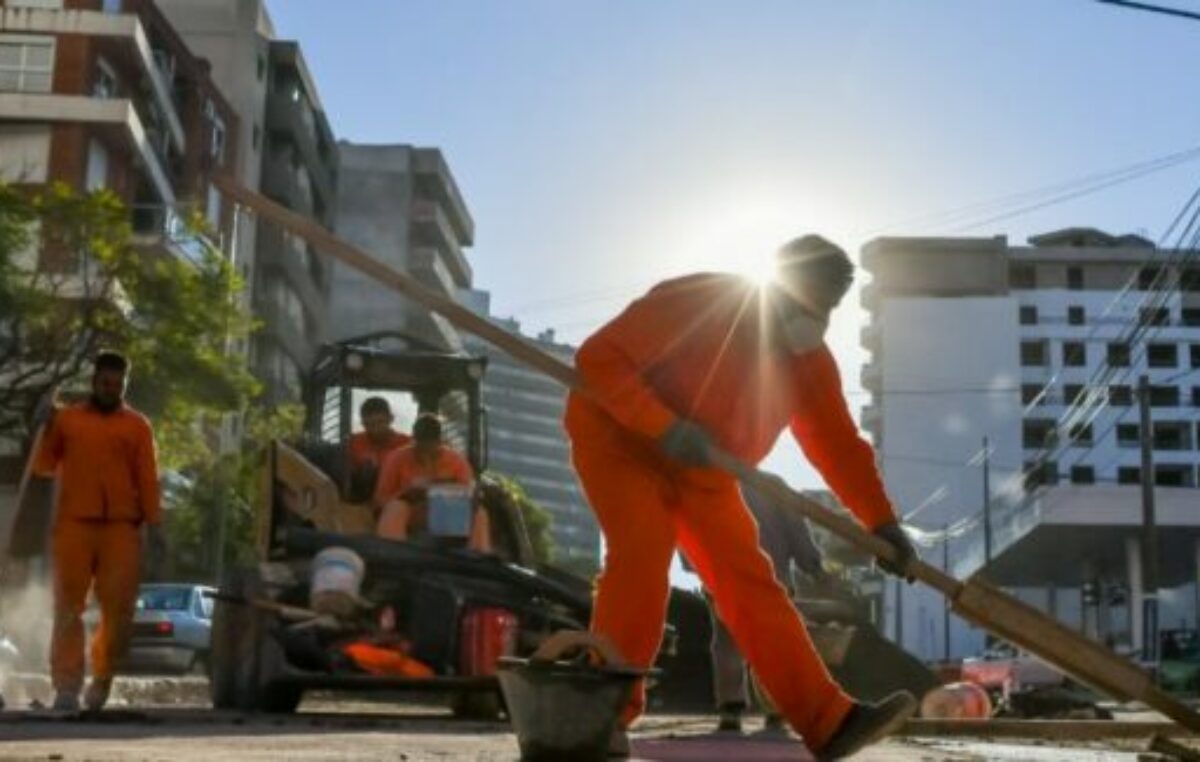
top-left (374, 413), bottom-right (492, 553)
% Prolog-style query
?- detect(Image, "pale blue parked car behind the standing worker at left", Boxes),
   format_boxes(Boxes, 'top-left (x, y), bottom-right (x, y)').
top-left (84, 583), bottom-right (215, 673)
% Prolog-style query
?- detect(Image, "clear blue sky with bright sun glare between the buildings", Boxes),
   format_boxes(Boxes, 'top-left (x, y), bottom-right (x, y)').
top-left (270, 0), bottom-right (1200, 494)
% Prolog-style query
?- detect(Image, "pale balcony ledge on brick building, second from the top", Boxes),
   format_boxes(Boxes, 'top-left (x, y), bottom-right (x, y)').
top-left (0, 92), bottom-right (175, 206)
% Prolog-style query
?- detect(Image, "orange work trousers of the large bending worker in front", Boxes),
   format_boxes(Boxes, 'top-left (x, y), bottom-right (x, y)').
top-left (566, 397), bottom-right (852, 750)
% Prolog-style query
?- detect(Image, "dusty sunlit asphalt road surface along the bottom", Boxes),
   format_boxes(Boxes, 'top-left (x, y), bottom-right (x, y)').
top-left (0, 701), bottom-right (1166, 762)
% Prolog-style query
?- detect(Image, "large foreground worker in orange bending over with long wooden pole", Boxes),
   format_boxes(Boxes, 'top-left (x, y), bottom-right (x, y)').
top-left (565, 235), bottom-right (916, 760)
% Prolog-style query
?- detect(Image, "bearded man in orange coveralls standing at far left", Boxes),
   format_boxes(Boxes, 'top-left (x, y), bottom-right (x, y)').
top-left (34, 352), bottom-right (166, 712)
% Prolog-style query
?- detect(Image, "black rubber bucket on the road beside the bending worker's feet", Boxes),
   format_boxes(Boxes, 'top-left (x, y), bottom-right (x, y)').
top-left (497, 659), bottom-right (643, 762)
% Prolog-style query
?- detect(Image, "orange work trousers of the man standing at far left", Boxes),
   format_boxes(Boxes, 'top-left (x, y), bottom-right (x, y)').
top-left (50, 518), bottom-right (142, 694)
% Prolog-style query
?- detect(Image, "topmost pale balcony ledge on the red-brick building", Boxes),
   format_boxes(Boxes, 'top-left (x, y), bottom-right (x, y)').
top-left (0, 7), bottom-right (184, 152)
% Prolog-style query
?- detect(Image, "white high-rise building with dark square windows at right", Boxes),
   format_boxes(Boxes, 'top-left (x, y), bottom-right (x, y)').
top-left (862, 229), bottom-right (1200, 659)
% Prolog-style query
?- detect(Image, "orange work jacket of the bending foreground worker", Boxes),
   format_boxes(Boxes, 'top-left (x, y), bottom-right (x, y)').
top-left (576, 274), bottom-right (894, 528)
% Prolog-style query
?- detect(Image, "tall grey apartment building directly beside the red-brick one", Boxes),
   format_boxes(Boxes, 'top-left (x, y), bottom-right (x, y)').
top-left (158, 0), bottom-right (337, 403)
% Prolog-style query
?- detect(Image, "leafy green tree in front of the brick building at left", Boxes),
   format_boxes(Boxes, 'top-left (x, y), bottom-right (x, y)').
top-left (0, 184), bottom-right (258, 469)
